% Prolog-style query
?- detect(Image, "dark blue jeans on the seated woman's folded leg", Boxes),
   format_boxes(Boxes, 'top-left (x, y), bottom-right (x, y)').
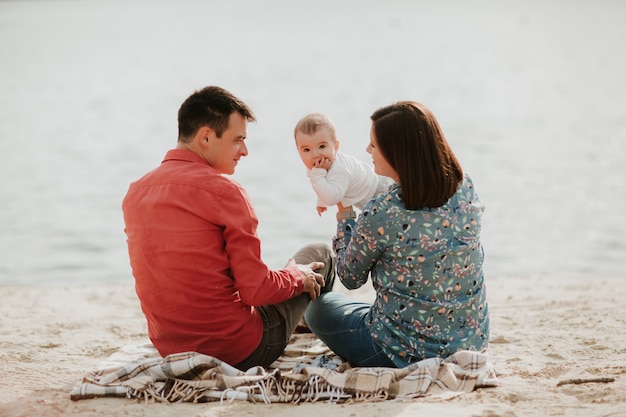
top-left (305, 292), bottom-right (396, 368)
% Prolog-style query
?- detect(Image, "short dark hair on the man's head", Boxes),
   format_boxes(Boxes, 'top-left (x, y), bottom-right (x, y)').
top-left (178, 86), bottom-right (256, 143)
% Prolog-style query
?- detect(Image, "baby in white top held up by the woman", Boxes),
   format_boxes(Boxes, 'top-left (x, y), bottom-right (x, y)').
top-left (294, 113), bottom-right (392, 216)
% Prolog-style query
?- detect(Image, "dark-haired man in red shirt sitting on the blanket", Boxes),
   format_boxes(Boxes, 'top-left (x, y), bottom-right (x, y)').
top-left (122, 86), bottom-right (334, 370)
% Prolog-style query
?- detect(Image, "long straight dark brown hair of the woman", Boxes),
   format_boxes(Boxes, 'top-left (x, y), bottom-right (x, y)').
top-left (370, 101), bottom-right (463, 210)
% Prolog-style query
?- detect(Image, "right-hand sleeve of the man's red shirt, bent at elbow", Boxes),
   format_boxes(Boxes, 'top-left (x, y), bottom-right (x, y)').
top-left (214, 182), bottom-right (304, 306)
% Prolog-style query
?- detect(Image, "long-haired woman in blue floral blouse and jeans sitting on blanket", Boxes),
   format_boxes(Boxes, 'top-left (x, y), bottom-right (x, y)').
top-left (306, 101), bottom-right (489, 367)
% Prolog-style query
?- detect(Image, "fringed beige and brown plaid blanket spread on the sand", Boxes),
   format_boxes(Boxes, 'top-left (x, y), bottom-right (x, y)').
top-left (70, 334), bottom-right (498, 403)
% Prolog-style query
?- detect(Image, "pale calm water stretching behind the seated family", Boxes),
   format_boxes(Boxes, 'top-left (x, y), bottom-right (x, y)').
top-left (0, 0), bottom-right (626, 285)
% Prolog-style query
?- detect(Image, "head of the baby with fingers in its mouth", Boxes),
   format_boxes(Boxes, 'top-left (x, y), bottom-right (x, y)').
top-left (293, 113), bottom-right (339, 169)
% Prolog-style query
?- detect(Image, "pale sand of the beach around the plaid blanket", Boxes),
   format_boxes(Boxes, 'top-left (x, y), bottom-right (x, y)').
top-left (0, 274), bottom-right (626, 417)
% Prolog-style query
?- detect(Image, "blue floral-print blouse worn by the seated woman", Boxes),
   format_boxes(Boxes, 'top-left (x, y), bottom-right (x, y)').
top-left (333, 176), bottom-right (489, 367)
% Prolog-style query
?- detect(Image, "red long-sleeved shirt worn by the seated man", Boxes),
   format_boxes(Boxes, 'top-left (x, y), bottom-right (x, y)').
top-left (122, 149), bottom-right (304, 365)
